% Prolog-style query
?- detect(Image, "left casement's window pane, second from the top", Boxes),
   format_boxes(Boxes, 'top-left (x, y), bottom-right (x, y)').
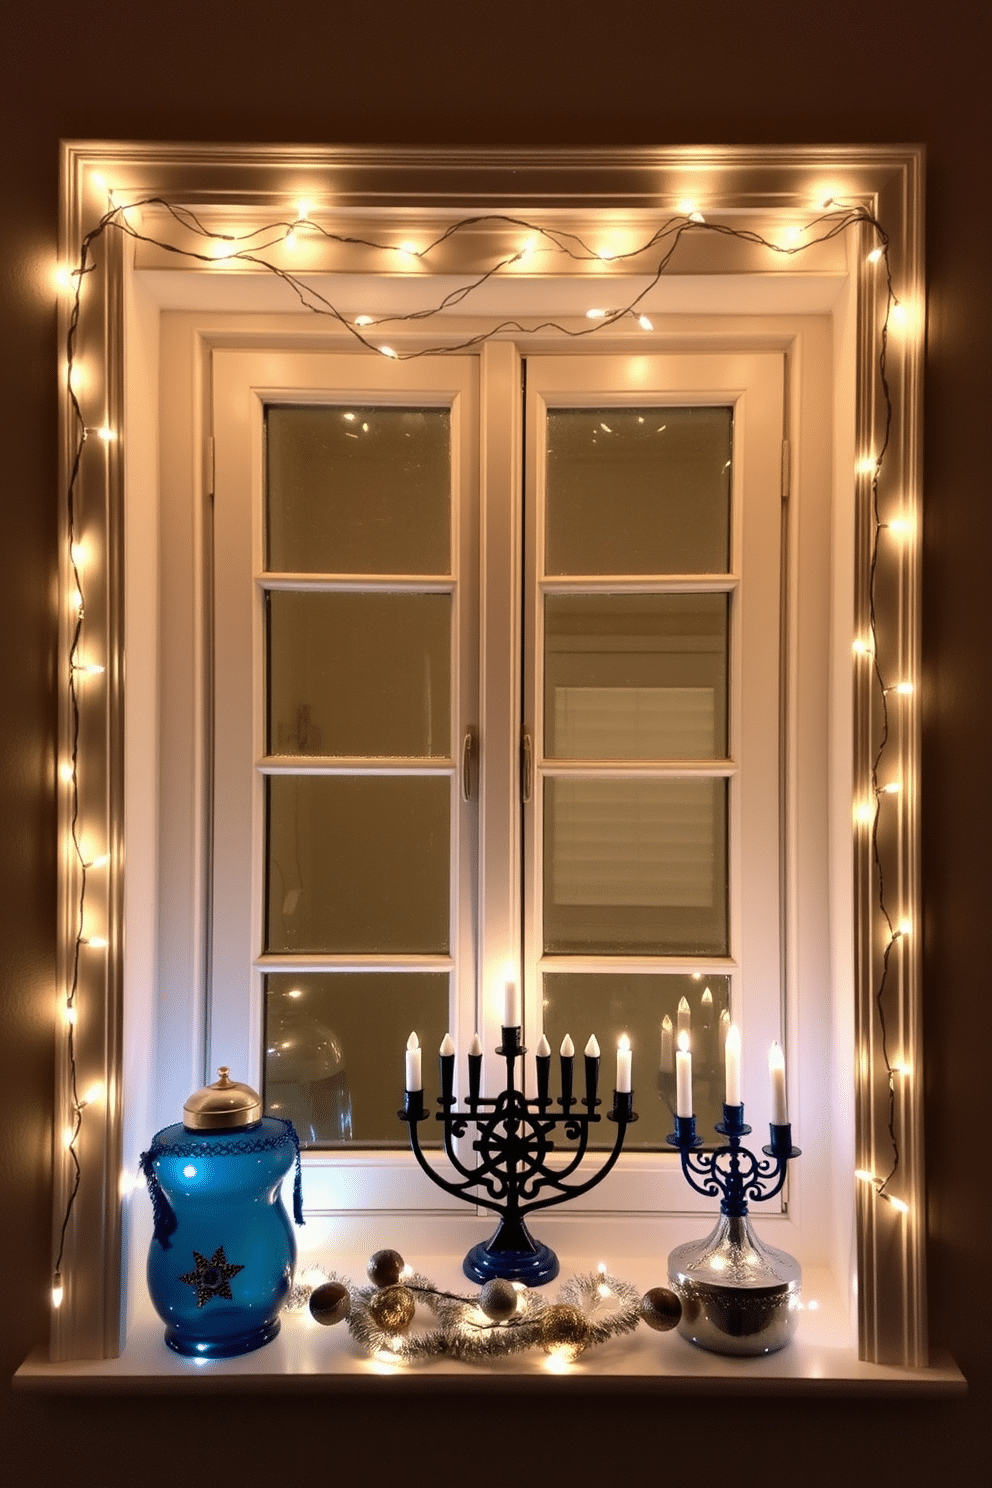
top-left (268, 591), bottom-right (451, 757)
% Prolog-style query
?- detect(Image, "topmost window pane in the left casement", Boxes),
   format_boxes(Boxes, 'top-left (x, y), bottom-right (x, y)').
top-left (265, 406), bottom-right (451, 574)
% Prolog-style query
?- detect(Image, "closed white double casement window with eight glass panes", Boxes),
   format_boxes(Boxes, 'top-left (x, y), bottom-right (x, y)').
top-left (209, 344), bottom-right (784, 1213)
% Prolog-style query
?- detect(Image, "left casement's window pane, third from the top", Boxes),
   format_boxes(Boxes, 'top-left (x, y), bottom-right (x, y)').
top-left (266, 775), bottom-right (451, 952)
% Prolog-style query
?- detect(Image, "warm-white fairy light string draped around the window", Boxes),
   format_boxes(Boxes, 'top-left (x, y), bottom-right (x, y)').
top-left (52, 190), bottom-right (912, 1305)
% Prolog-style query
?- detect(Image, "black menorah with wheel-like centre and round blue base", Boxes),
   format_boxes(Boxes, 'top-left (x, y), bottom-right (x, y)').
top-left (397, 1027), bottom-right (637, 1286)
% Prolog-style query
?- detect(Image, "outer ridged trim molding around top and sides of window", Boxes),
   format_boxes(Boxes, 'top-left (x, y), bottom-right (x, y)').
top-left (51, 141), bottom-right (927, 1367)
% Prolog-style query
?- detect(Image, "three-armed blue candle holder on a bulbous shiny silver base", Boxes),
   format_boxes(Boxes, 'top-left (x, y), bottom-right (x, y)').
top-left (668, 1104), bottom-right (802, 1354)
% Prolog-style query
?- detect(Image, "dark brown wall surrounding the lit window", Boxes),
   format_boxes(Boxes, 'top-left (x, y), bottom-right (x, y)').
top-left (0, 0), bottom-right (992, 1488)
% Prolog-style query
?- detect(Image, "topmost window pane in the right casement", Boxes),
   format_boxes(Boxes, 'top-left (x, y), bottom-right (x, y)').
top-left (546, 408), bottom-right (733, 574)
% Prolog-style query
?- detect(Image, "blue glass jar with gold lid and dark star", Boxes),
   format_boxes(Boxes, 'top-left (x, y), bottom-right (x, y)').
top-left (141, 1068), bottom-right (302, 1359)
